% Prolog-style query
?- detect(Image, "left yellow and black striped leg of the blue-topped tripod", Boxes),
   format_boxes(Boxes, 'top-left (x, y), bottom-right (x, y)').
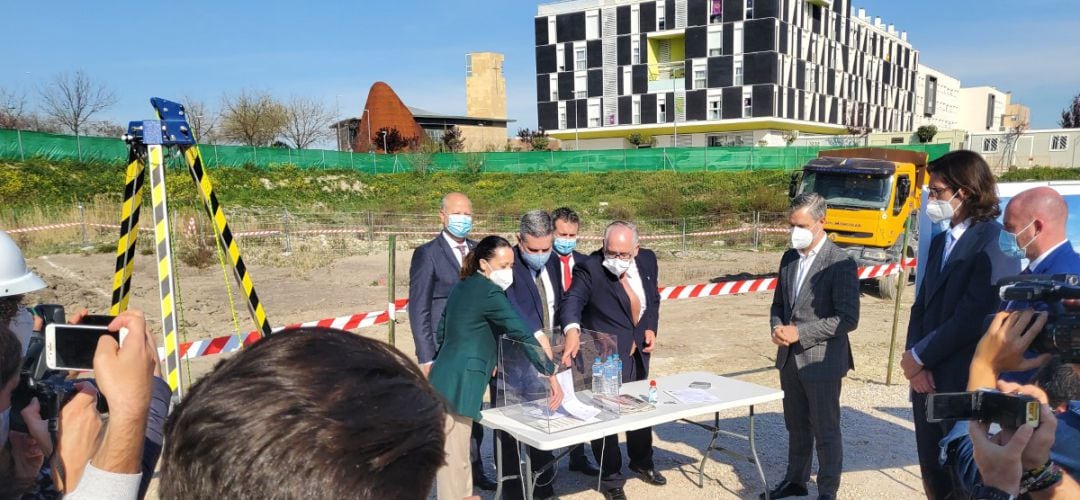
top-left (109, 151), bottom-right (146, 315)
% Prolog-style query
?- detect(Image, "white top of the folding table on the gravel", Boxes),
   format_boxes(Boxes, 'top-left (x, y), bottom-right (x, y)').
top-left (481, 371), bottom-right (784, 450)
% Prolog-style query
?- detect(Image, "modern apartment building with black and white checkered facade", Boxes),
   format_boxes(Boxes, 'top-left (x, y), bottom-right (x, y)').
top-left (536, 0), bottom-right (919, 149)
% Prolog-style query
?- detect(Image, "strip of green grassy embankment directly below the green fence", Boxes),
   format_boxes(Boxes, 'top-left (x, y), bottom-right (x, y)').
top-left (0, 160), bottom-right (788, 217)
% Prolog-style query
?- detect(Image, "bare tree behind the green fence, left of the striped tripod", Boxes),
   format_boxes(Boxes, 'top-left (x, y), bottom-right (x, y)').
top-left (38, 70), bottom-right (117, 136)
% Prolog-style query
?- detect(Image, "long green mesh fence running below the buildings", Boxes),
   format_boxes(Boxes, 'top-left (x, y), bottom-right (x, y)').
top-left (0, 130), bottom-right (949, 174)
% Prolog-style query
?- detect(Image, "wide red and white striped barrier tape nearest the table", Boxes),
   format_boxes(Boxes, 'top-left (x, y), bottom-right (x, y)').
top-left (172, 259), bottom-right (916, 360)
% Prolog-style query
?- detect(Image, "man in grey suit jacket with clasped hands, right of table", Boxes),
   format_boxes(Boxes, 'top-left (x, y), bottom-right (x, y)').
top-left (761, 192), bottom-right (859, 500)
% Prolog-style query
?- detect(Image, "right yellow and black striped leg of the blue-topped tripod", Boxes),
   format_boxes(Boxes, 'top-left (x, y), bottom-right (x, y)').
top-left (184, 146), bottom-right (271, 337)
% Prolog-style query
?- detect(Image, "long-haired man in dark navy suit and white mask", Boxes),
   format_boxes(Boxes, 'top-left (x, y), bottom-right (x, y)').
top-left (901, 150), bottom-right (1020, 500)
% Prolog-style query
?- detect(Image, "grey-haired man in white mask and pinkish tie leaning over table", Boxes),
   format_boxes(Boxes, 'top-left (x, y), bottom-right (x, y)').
top-left (559, 220), bottom-right (667, 499)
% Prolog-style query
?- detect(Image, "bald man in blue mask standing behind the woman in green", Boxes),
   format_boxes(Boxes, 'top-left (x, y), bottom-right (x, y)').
top-left (408, 192), bottom-right (496, 491)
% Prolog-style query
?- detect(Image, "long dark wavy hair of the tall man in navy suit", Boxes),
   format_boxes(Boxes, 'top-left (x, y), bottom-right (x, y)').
top-left (927, 149), bottom-right (1001, 221)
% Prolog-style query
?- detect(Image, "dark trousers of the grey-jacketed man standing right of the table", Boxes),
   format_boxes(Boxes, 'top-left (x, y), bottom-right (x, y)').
top-left (780, 356), bottom-right (843, 496)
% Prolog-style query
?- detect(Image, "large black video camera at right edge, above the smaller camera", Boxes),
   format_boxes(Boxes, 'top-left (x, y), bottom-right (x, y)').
top-left (998, 274), bottom-right (1080, 363)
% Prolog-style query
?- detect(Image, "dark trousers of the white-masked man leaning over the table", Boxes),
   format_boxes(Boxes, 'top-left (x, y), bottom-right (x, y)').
top-left (591, 350), bottom-right (656, 489)
